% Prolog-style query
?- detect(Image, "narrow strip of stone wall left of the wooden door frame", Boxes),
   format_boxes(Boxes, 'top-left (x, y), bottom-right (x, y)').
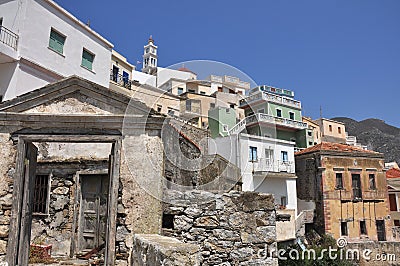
top-left (0, 134), bottom-right (17, 261)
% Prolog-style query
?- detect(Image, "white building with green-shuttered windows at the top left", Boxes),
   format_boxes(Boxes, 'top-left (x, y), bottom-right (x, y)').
top-left (0, 0), bottom-right (113, 99)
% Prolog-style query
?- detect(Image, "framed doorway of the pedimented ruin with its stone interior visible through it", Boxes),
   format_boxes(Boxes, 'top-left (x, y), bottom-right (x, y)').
top-left (7, 136), bottom-right (121, 265)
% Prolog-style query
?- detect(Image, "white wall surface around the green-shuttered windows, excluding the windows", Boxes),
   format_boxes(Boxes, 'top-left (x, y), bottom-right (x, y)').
top-left (0, 0), bottom-right (112, 99)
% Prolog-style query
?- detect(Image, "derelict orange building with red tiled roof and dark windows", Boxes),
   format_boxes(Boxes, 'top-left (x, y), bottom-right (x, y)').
top-left (295, 142), bottom-right (392, 242)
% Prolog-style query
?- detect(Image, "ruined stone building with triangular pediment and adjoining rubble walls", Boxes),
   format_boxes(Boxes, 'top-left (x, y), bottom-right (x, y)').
top-left (0, 77), bottom-right (277, 266)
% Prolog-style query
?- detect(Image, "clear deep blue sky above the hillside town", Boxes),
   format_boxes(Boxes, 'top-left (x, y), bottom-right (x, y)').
top-left (56, 0), bottom-right (400, 127)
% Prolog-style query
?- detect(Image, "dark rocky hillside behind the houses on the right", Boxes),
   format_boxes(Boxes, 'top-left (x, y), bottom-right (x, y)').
top-left (332, 117), bottom-right (400, 163)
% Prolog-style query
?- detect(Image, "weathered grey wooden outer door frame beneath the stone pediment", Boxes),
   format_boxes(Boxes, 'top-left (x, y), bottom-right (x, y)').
top-left (6, 135), bottom-right (122, 266)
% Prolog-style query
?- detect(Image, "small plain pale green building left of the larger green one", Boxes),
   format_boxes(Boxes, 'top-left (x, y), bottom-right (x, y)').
top-left (208, 107), bottom-right (236, 138)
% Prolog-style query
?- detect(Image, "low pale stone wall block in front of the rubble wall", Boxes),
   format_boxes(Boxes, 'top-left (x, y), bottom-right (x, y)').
top-left (131, 234), bottom-right (201, 266)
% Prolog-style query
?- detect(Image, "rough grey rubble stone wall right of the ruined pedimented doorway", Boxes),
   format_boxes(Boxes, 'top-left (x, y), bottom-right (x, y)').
top-left (163, 190), bottom-right (278, 265)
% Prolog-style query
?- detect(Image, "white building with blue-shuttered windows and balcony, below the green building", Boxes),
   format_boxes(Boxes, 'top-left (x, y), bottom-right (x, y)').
top-left (209, 133), bottom-right (299, 241)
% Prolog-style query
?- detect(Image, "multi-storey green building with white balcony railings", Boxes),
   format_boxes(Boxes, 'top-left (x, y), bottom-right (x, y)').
top-left (230, 85), bottom-right (314, 148)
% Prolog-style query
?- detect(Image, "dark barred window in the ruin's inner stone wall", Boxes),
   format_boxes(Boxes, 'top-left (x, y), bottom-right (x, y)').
top-left (32, 175), bottom-right (49, 214)
